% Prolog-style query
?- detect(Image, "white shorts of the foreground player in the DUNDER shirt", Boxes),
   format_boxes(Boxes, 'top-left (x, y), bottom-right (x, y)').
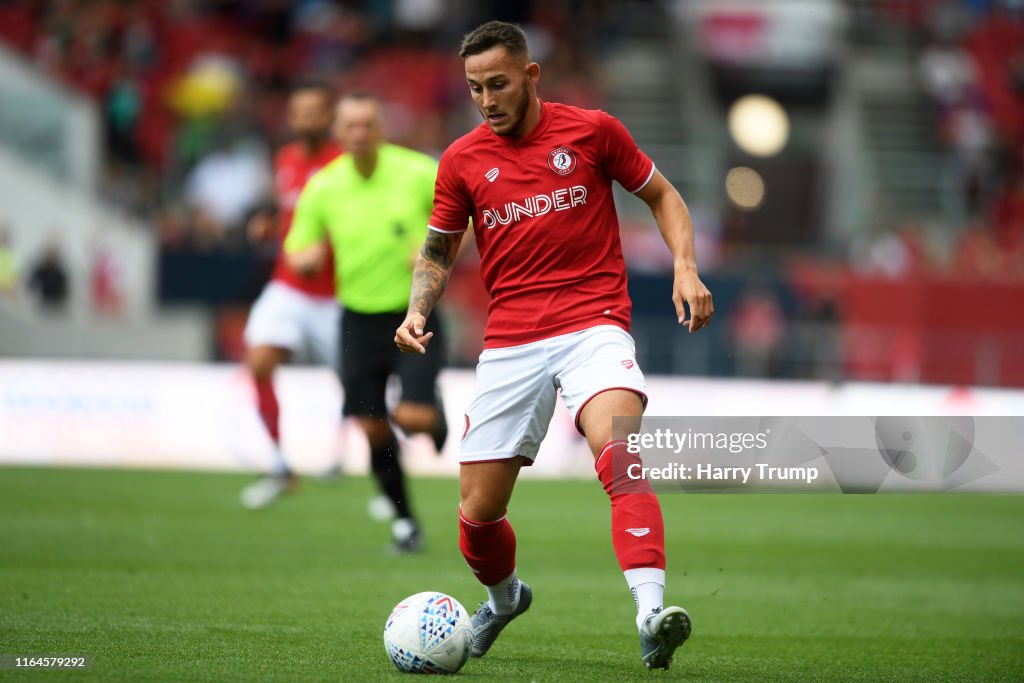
top-left (460, 325), bottom-right (647, 463)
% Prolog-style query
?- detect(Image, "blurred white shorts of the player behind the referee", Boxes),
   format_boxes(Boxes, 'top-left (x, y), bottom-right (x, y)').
top-left (245, 282), bottom-right (341, 368)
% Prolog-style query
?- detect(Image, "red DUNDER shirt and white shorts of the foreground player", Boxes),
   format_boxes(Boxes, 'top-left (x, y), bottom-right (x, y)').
top-left (430, 102), bottom-right (654, 462)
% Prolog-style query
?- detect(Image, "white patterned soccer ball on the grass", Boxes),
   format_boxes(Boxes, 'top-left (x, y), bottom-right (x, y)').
top-left (384, 591), bottom-right (472, 674)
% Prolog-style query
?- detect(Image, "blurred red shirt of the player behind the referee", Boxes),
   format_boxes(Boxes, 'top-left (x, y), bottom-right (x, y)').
top-left (272, 140), bottom-right (341, 298)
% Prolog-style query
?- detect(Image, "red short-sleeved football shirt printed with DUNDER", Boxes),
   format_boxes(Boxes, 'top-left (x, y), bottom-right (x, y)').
top-left (430, 102), bottom-right (654, 348)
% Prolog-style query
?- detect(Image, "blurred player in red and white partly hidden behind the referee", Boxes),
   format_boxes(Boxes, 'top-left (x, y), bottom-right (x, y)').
top-left (242, 82), bottom-right (341, 509)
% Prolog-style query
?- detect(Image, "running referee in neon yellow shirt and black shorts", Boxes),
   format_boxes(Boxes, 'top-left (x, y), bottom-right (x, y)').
top-left (285, 93), bottom-right (447, 553)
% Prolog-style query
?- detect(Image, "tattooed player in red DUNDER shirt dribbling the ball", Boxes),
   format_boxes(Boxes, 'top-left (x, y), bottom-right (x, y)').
top-left (395, 22), bottom-right (714, 669)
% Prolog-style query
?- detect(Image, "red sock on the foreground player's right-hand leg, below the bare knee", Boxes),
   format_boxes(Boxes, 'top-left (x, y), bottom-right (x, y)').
top-left (594, 440), bottom-right (665, 571)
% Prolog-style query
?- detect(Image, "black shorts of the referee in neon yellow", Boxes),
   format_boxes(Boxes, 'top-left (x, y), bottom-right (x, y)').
top-left (341, 308), bottom-right (445, 418)
